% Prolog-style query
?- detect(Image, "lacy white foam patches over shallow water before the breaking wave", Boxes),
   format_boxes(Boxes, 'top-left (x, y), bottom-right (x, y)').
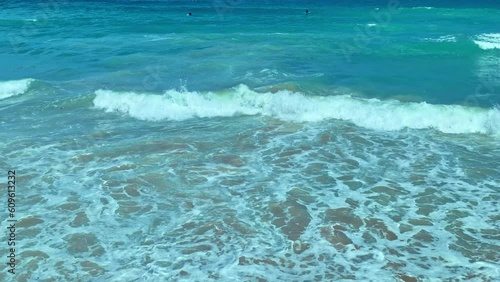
top-left (15, 92), bottom-right (500, 281)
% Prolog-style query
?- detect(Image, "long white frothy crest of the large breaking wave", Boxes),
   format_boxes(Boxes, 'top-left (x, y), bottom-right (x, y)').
top-left (94, 85), bottom-right (500, 134)
